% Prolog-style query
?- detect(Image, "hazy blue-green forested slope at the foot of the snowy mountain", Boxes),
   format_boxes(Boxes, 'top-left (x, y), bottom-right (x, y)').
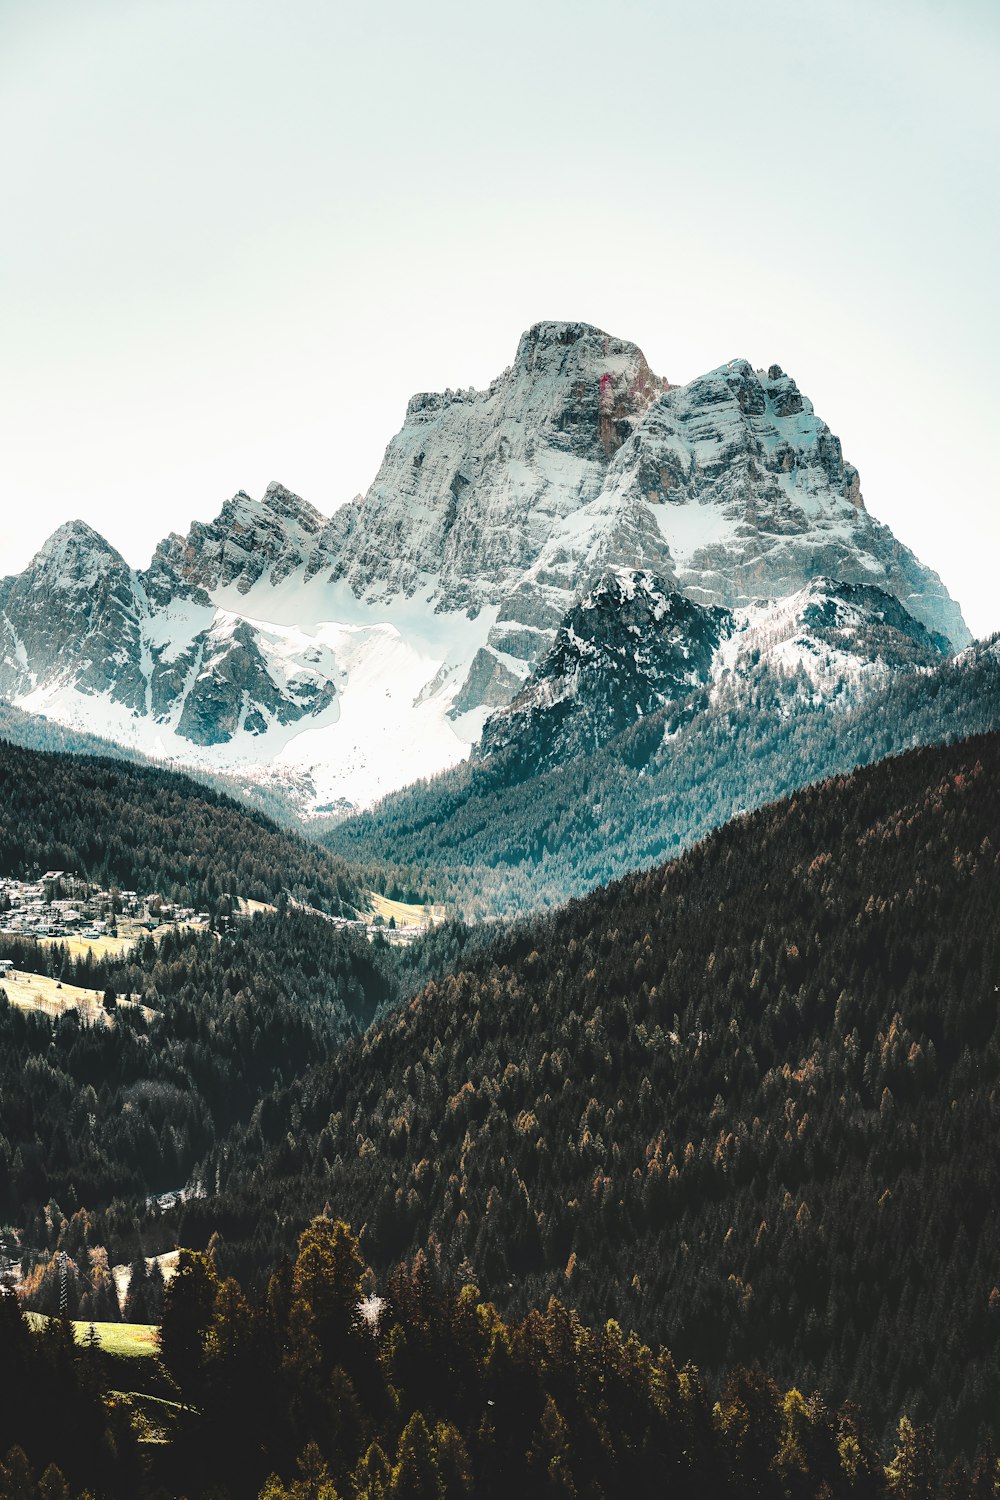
top-left (322, 639), bottom-right (1000, 918)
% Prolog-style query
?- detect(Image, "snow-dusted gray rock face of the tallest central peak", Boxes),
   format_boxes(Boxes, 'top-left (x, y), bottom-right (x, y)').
top-left (301, 323), bottom-right (664, 612)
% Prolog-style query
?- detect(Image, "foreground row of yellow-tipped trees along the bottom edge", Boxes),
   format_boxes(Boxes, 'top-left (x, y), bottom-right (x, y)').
top-left (0, 1218), bottom-right (999, 1500)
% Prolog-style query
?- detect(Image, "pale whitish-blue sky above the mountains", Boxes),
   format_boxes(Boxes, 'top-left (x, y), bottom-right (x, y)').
top-left (0, 0), bottom-right (1000, 635)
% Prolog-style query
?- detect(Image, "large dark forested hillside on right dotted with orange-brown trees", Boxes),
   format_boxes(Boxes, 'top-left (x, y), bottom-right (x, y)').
top-left (185, 735), bottom-right (1000, 1452)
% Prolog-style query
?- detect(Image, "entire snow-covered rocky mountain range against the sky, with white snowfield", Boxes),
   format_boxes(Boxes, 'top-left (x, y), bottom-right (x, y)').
top-left (0, 323), bottom-right (970, 810)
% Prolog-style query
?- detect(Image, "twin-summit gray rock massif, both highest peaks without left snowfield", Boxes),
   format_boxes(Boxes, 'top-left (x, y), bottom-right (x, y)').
top-left (296, 323), bottom-right (969, 720)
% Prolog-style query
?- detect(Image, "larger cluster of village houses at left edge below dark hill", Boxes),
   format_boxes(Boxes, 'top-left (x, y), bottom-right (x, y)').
top-left (0, 870), bottom-right (208, 939)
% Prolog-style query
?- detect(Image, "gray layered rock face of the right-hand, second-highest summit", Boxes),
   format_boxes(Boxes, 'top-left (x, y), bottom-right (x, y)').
top-left (593, 360), bottom-right (970, 648)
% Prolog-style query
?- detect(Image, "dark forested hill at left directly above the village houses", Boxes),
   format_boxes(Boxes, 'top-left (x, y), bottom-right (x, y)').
top-left (0, 741), bottom-right (363, 912)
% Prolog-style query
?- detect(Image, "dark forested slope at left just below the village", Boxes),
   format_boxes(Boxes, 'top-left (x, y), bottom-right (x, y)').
top-left (0, 909), bottom-right (397, 1236)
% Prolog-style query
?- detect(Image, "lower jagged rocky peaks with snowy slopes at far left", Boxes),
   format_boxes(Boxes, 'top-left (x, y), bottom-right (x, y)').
top-left (0, 489), bottom-right (336, 753)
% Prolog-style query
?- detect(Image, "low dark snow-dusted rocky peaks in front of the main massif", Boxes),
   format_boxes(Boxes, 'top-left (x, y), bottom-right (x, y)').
top-left (474, 569), bottom-right (949, 780)
